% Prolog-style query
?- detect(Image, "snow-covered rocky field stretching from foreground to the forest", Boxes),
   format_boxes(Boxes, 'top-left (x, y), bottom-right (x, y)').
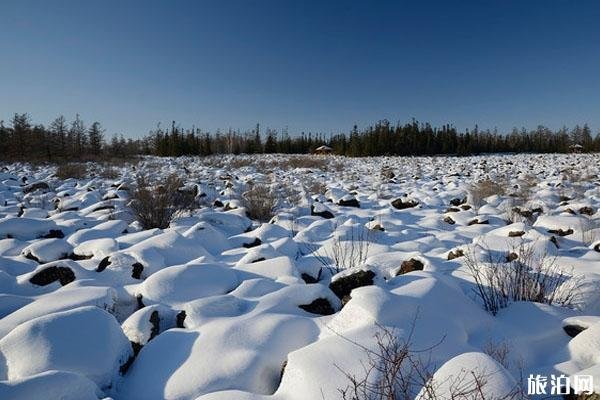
top-left (0, 154), bottom-right (600, 400)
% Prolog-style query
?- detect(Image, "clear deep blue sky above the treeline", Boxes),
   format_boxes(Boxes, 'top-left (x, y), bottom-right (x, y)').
top-left (0, 0), bottom-right (600, 136)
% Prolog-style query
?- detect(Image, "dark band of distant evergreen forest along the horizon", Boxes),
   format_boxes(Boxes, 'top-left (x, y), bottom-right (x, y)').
top-left (0, 114), bottom-right (600, 162)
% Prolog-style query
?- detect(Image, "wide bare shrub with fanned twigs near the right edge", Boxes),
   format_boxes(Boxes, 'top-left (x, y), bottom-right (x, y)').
top-left (464, 242), bottom-right (582, 315)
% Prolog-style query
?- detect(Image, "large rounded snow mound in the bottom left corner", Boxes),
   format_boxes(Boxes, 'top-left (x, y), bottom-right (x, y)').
top-left (0, 306), bottom-right (132, 388)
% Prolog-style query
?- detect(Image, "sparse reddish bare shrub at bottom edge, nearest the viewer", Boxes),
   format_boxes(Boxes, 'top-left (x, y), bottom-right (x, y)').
top-left (336, 321), bottom-right (524, 400)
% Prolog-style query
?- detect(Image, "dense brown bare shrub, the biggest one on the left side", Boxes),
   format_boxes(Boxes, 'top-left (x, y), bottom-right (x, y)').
top-left (130, 175), bottom-right (195, 229)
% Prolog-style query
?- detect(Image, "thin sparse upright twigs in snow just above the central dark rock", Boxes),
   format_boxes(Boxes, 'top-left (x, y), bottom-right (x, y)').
top-left (312, 223), bottom-right (371, 273)
